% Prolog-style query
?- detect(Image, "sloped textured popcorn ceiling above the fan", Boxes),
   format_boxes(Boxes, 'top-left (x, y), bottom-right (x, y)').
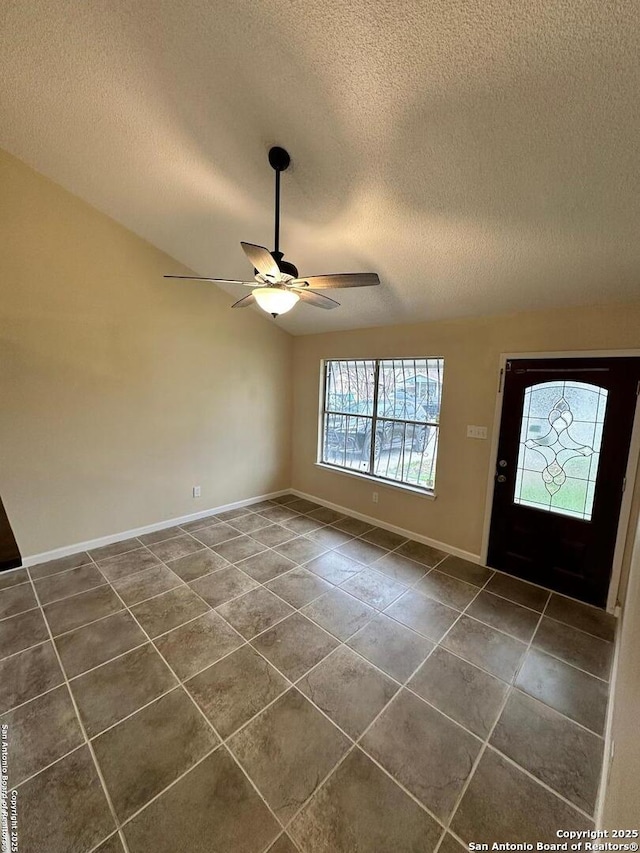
top-left (0, 0), bottom-right (640, 334)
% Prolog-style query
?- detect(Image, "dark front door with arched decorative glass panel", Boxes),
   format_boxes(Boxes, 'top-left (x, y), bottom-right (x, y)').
top-left (488, 358), bottom-right (640, 607)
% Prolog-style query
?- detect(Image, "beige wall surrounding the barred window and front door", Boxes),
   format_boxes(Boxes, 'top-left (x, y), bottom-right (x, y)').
top-left (293, 302), bottom-right (640, 600)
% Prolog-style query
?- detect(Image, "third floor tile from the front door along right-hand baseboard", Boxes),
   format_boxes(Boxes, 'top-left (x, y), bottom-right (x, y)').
top-left (516, 649), bottom-right (608, 734)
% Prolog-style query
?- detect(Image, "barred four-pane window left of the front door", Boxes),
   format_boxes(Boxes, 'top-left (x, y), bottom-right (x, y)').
top-left (320, 358), bottom-right (444, 491)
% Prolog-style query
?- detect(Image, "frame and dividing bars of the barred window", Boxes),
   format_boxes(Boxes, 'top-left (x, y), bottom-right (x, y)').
top-left (316, 355), bottom-right (444, 500)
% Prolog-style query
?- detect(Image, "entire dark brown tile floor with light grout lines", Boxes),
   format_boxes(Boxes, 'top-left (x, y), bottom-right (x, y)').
top-left (0, 495), bottom-right (615, 853)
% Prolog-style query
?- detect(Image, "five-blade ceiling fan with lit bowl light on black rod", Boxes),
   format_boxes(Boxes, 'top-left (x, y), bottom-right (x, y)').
top-left (165, 146), bottom-right (380, 317)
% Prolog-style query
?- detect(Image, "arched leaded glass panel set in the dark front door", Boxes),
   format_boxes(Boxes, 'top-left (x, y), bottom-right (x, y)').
top-left (514, 380), bottom-right (608, 521)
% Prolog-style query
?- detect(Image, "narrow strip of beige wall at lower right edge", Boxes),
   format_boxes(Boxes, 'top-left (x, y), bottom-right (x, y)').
top-left (601, 512), bottom-right (640, 824)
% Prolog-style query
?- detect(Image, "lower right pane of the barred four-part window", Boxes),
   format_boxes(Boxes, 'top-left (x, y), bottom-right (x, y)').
top-left (374, 420), bottom-right (438, 489)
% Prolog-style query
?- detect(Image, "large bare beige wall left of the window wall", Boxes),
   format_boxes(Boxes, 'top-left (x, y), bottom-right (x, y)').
top-left (0, 152), bottom-right (292, 556)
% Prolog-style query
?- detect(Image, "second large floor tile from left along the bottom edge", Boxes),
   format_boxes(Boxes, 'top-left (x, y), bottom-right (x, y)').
top-left (124, 747), bottom-right (281, 853)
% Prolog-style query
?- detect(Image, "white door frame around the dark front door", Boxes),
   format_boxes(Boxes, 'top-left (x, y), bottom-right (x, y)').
top-left (480, 349), bottom-right (640, 613)
